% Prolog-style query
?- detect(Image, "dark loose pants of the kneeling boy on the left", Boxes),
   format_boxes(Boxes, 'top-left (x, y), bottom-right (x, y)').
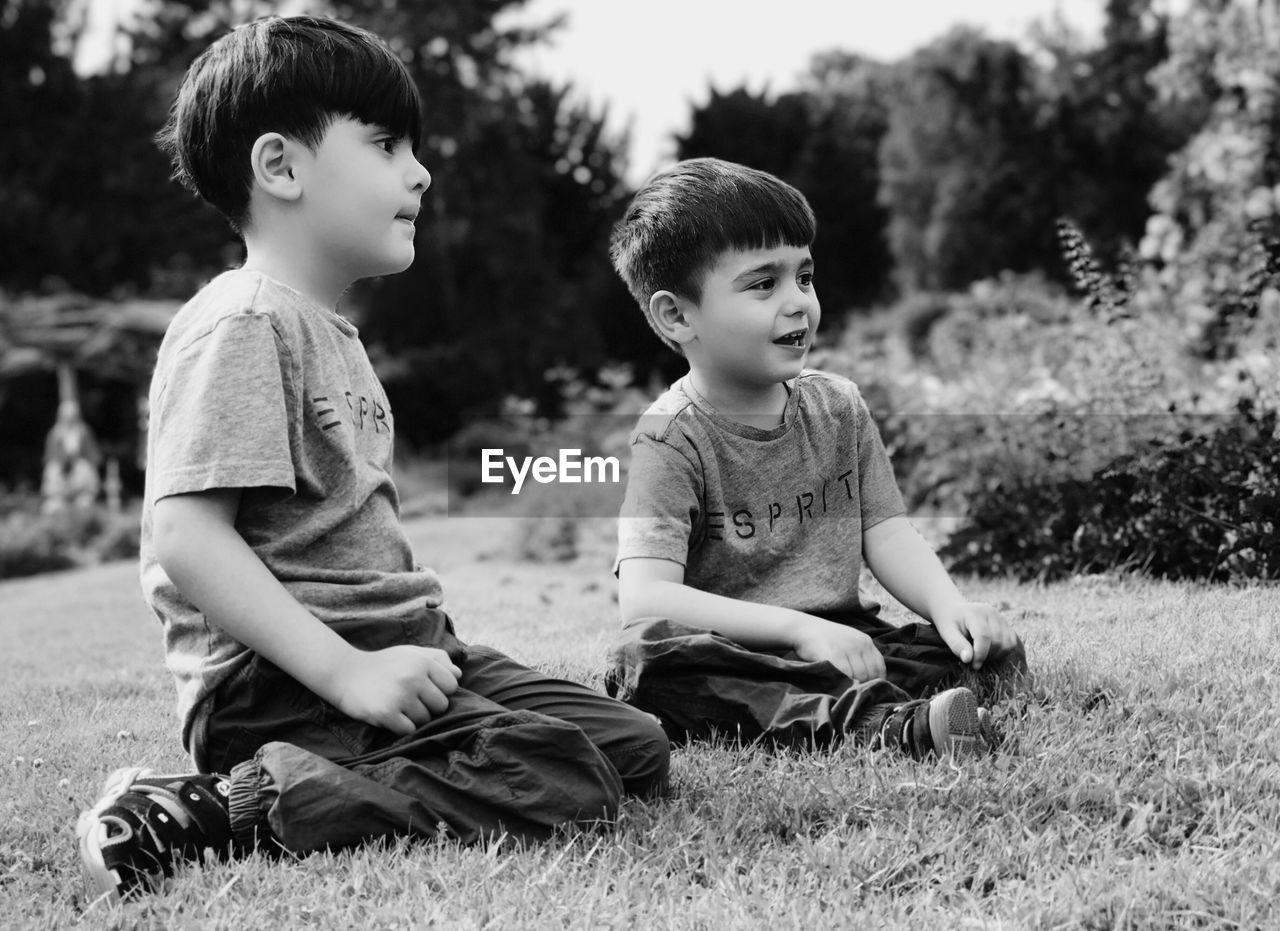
top-left (196, 612), bottom-right (669, 853)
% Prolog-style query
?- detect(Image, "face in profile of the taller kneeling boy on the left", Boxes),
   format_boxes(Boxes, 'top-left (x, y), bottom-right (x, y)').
top-left (296, 118), bottom-right (431, 284)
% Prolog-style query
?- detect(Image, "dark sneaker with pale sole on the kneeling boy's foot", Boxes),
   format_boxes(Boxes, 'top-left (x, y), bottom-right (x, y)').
top-left (76, 767), bottom-right (232, 902)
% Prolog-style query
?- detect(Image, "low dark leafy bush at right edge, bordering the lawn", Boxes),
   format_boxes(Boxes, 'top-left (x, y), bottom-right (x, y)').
top-left (942, 400), bottom-right (1280, 581)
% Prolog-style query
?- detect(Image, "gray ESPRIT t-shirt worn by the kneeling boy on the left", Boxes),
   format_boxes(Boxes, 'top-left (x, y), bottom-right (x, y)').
top-left (141, 270), bottom-right (443, 748)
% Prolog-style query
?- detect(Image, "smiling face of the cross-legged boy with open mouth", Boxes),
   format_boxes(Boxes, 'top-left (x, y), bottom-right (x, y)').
top-left (685, 240), bottom-right (822, 394)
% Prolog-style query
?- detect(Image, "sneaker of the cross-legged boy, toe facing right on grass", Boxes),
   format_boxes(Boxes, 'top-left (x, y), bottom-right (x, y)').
top-left (876, 689), bottom-right (991, 759)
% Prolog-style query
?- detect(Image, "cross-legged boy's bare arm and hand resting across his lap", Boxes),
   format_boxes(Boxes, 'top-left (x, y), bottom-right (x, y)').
top-left (618, 557), bottom-right (884, 681)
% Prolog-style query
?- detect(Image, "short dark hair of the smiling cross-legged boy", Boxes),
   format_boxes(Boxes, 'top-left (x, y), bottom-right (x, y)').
top-left (609, 159), bottom-right (817, 352)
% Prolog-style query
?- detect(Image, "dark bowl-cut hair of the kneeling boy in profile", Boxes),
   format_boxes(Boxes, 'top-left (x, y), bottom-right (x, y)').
top-left (156, 17), bottom-right (422, 232)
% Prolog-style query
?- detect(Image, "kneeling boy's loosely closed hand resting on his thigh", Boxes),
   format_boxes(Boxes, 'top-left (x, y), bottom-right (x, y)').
top-left (329, 645), bottom-right (462, 735)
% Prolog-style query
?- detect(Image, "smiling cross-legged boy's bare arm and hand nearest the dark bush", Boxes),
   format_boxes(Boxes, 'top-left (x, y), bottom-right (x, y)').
top-left (863, 517), bottom-right (1018, 670)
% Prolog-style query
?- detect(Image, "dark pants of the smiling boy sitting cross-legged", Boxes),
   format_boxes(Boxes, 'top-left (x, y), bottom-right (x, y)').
top-left (605, 611), bottom-right (1027, 747)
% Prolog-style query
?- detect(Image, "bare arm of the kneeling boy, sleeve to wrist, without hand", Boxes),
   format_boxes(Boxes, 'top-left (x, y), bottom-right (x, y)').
top-left (155, 492), bottom-right (353, 697)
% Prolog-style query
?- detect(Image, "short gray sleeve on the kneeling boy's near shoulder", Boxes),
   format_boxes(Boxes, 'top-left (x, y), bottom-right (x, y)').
top-left (147, 314), bottom-right (296, 501)
